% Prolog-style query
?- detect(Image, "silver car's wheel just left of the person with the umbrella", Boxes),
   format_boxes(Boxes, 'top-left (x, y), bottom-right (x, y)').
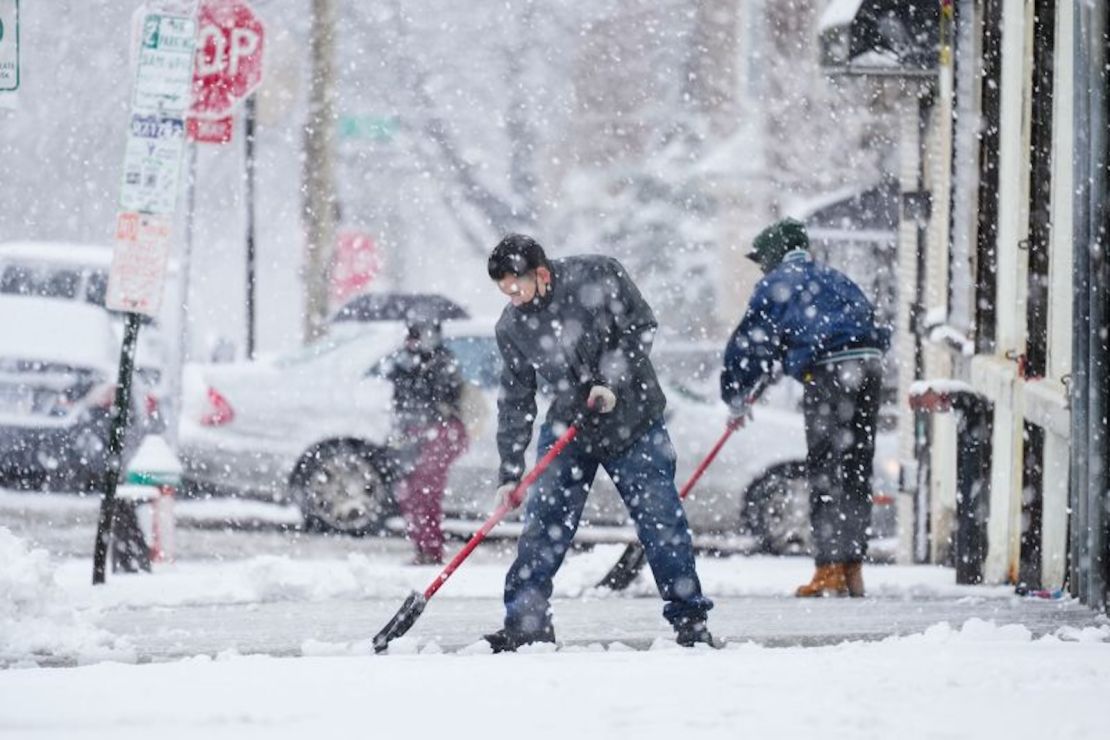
top-left (292, 440), bottom-right (396, 535)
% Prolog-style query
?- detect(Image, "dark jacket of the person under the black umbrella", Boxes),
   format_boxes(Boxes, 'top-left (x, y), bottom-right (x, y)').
top-left (385, 346), bottom-right (463, 430)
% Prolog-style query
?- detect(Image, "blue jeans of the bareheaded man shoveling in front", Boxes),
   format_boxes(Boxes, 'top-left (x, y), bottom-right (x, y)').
top-left (505, 418), bottom-right (713, 632)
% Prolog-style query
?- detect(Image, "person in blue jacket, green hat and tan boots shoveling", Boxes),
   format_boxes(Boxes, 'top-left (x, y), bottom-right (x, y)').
top-left (720, 219), bottom-right (890, 597)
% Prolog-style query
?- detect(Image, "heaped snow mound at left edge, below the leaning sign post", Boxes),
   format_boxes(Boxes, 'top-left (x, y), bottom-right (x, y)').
top-left (0, 527), bottom-right (130, 666)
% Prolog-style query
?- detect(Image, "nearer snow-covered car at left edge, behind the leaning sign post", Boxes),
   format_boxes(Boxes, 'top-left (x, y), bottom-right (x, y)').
top-left (0, 295), bottom-right (144, 490)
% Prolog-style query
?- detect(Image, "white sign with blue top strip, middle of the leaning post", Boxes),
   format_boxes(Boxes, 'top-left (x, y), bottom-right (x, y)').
top-left (120, 113), bottom-right (185, 214)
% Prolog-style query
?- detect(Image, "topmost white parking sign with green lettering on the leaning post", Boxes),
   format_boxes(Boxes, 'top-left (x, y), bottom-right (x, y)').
top-left (131, 12), bottom-right (196, 118)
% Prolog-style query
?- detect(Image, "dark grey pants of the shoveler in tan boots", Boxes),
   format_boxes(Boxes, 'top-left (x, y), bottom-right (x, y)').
top-left (804, 359), bottom-right (882, 566)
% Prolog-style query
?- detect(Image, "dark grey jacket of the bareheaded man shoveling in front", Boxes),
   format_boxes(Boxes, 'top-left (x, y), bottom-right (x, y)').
top-left (496, 256), bottom-right (666, 483)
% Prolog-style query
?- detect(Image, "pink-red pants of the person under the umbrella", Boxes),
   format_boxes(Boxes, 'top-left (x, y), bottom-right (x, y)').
top-left (395, 419), bottom-right (466, 559)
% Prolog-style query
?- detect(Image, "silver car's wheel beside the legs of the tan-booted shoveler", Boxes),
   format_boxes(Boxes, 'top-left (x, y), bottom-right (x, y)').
top-left (740, 463), bottom-right (813, 555)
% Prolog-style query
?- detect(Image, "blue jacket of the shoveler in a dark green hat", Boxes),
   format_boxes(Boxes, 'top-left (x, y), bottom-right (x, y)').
top-left (720, 250), bottom-right (890, 403)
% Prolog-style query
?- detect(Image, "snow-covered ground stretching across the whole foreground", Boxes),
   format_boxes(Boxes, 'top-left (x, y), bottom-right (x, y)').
top-left (0, 491), bottom-right (1110, 738)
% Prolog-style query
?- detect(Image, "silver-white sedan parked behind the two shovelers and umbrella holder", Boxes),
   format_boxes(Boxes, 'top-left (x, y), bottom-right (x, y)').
top-left (180, 320), bottom-right (894, 553)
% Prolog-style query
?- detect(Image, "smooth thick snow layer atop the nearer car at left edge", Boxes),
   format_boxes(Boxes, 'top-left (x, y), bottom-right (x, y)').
top-left (0, 295), bottom-right (119, 375)
